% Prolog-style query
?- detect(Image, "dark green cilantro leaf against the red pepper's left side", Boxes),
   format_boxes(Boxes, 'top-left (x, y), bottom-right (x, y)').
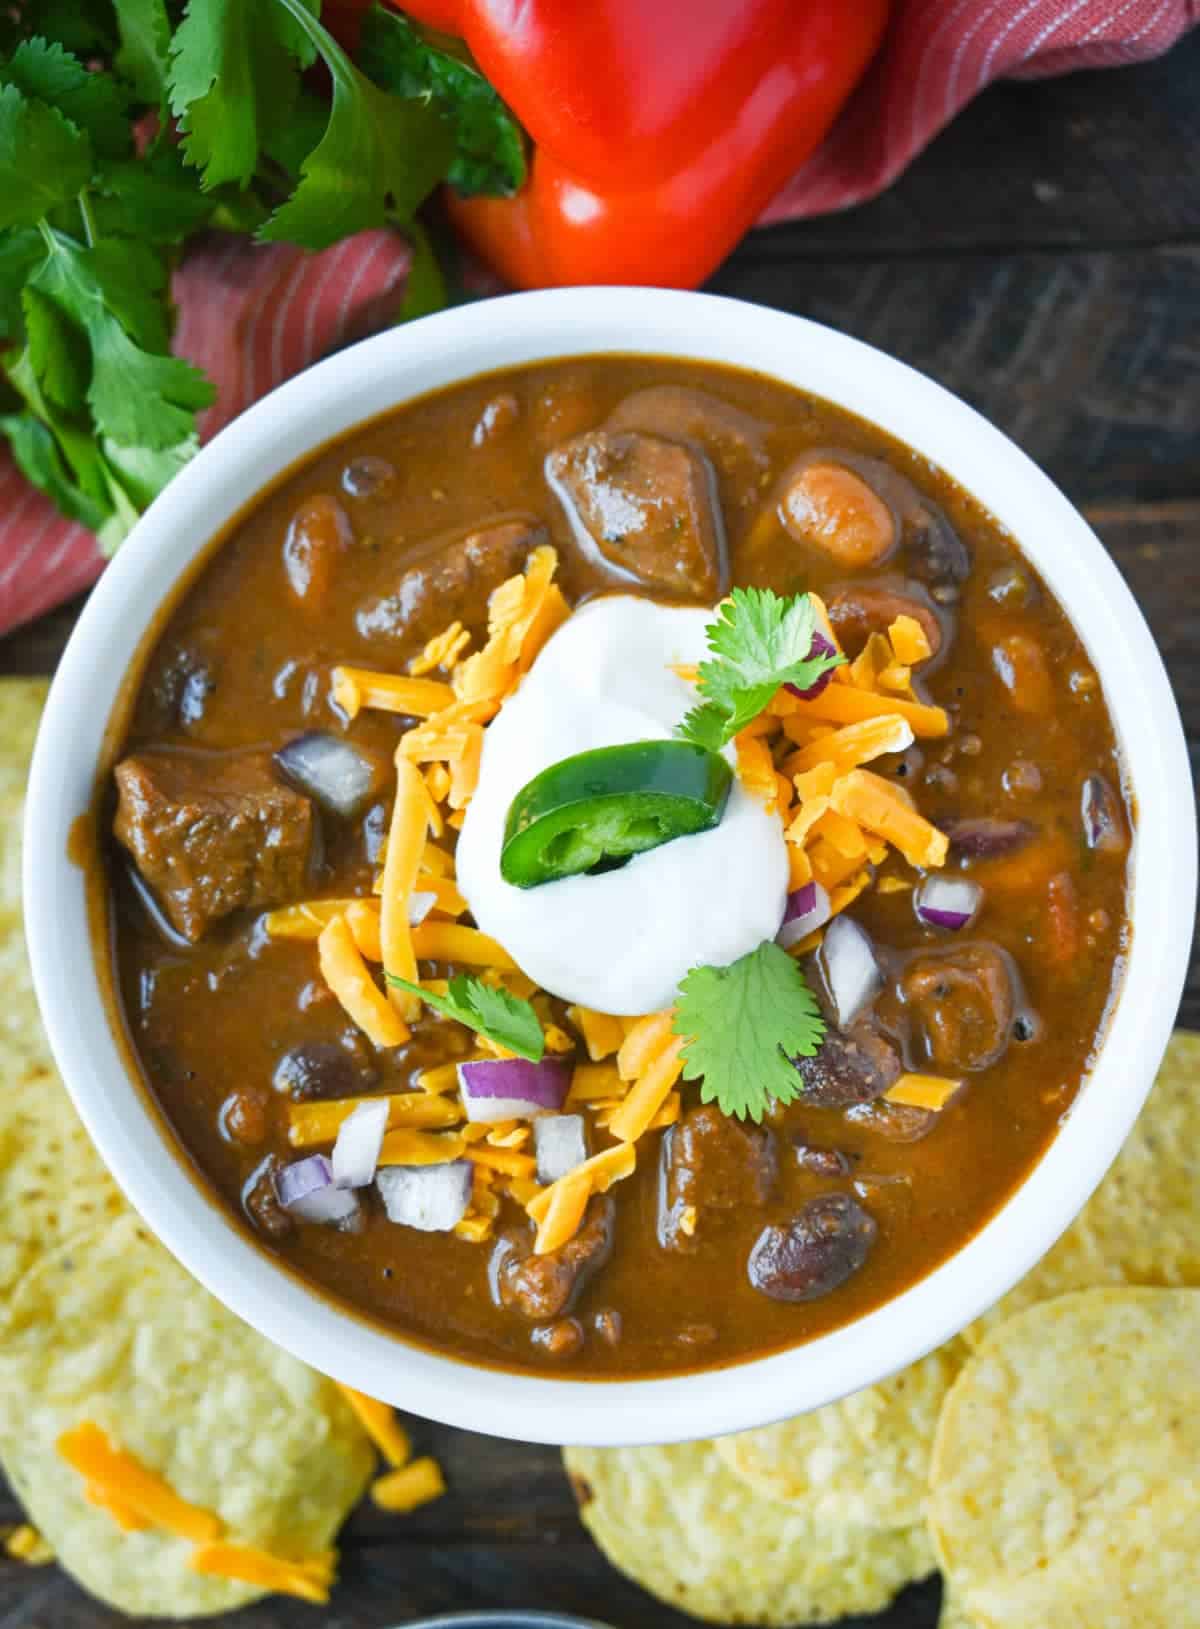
top-left (358, 5), bottom-right (526, 197)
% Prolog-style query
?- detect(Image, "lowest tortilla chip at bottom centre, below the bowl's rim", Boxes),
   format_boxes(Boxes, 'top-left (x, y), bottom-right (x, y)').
top-left (563, 1442), bottom-right (935, 1626)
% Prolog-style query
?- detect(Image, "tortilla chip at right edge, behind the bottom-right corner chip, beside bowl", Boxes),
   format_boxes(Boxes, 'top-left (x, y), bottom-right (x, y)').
top-left (964, 1030), bottom-right (1200, 1346)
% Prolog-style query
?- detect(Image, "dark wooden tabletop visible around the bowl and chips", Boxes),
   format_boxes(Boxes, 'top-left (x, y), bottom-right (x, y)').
top-left (0, 36), bottom-right (1200, 1629)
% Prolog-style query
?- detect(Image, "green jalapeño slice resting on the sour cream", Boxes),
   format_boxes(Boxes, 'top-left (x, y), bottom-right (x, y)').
top-left (500, 741), bottom-right (733, 888)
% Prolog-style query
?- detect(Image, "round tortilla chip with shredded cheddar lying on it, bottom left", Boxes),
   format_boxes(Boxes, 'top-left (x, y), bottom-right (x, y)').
top-left (0, 1214), bottom-right (374, 1618)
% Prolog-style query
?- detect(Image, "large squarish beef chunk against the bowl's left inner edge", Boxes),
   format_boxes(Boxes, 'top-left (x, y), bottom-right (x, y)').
top-left (112, 753), bottom-right (313, 942)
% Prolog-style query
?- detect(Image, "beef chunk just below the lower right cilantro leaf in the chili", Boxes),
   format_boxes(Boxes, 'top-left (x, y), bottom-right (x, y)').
top-left (658, 1103), bottom-right (777, 1251)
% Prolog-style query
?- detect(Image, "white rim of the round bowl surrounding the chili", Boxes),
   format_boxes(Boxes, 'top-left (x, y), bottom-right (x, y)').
top-left (24, 288), bottom-right (1195, 1445)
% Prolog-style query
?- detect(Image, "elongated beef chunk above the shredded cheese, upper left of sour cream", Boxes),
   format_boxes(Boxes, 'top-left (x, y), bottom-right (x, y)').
top-left (355, 520), bottom-right (545, 643)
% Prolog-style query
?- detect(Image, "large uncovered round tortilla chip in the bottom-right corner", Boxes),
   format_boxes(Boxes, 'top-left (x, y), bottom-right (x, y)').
top-left (930, 1289), bottom-right (1200, 1629)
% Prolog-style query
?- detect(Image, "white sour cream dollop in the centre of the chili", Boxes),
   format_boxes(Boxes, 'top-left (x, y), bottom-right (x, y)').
top-left (458, 595), bottom-right (788, 1016)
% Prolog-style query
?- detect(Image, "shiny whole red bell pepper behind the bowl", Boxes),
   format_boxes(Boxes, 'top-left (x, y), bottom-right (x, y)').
top-left (402, 0), bottom-right (889, 288)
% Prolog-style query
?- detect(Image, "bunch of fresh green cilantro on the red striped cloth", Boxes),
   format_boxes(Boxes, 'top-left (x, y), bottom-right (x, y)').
top-left (0, 0), bottom-right (524, 552)
